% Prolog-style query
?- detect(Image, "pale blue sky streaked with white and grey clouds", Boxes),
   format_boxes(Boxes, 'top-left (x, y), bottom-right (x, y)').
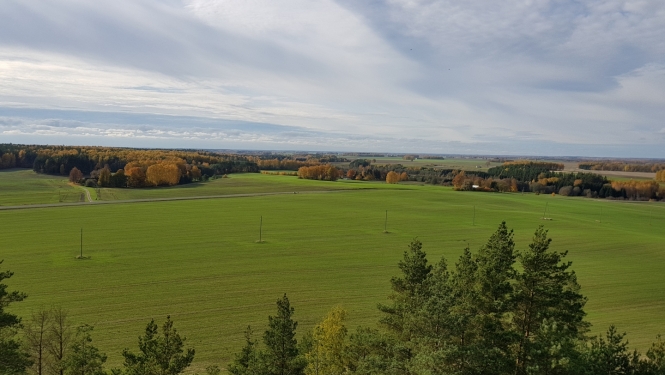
top-left (0, 0), bottom-right (665, 158)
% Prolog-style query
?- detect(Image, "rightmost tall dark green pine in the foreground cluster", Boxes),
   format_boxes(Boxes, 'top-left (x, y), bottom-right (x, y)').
top-left (512, 226), bottom-right (588, 374)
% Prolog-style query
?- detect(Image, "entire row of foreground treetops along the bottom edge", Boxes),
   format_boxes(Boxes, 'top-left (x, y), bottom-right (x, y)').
top-left (0, 223), bottom-right (665, 375)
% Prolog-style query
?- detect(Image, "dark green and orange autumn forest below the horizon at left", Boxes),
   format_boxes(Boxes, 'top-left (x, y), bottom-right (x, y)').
top-left (0, 144), bottom-right (259, 188)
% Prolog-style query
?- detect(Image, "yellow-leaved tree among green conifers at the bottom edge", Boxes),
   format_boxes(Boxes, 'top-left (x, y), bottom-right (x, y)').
top-left (305, 306), bottom-right (348, 375)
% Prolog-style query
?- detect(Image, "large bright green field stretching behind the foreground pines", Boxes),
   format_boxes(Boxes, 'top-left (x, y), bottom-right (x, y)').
top-left (0, 174), bottom-right (665, 370)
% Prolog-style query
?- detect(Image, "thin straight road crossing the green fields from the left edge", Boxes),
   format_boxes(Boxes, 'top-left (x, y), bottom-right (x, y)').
top-left (0, 189), bottom-right (373, 211)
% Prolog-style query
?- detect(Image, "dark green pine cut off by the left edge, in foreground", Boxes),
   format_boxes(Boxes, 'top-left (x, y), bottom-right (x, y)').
top-left (0, 260), bottom-right (31, 375)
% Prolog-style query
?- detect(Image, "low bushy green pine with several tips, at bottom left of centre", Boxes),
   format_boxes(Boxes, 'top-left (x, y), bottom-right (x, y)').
top-left (122, 316), bottom-right (194, 375)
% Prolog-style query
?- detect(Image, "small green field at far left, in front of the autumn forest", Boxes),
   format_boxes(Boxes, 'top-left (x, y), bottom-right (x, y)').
top-left (0, 169), bottom-right (83, 206)
